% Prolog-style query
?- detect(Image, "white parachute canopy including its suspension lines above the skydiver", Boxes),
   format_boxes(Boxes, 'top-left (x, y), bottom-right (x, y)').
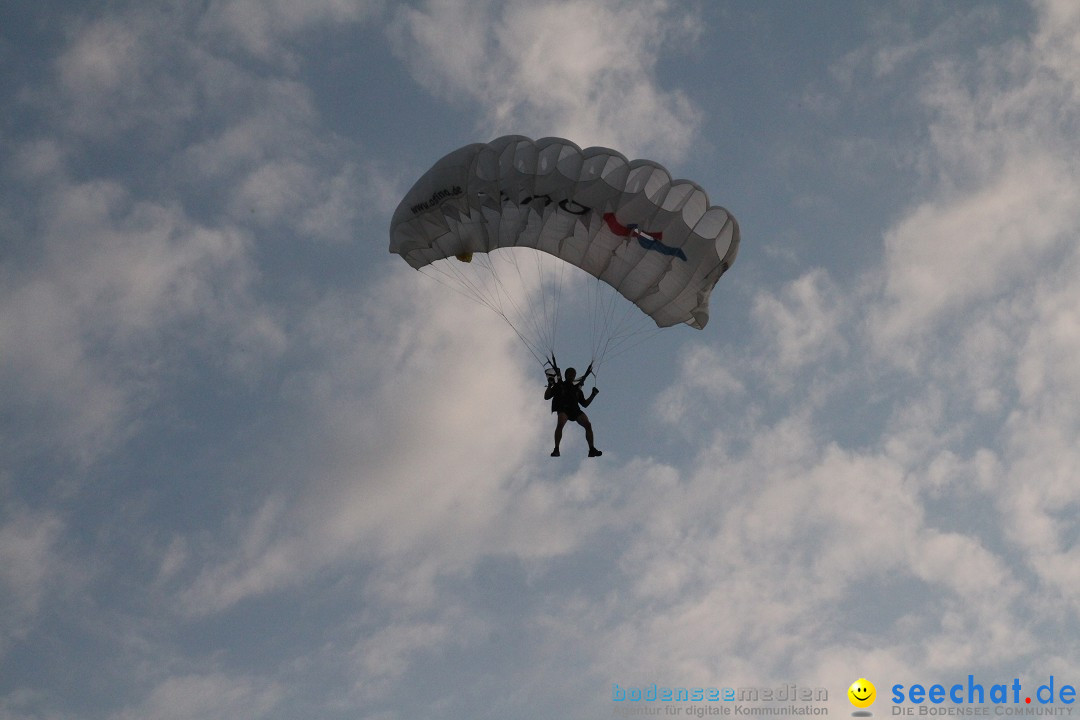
top-left (390, 135), bottom-right (739, 367)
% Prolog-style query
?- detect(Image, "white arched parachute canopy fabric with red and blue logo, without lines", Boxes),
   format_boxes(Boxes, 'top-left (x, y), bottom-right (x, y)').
top-left (390, 135), bottom-right (739, 367)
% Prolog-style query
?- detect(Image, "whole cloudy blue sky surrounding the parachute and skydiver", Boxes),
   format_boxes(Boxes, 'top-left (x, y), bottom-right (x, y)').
top-left (0, 0), bottom-right (1080, 720)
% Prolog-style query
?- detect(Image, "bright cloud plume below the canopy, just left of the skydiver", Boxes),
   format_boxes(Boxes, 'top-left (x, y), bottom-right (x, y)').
top-left (171, 269), bottom-right (561, 613)
